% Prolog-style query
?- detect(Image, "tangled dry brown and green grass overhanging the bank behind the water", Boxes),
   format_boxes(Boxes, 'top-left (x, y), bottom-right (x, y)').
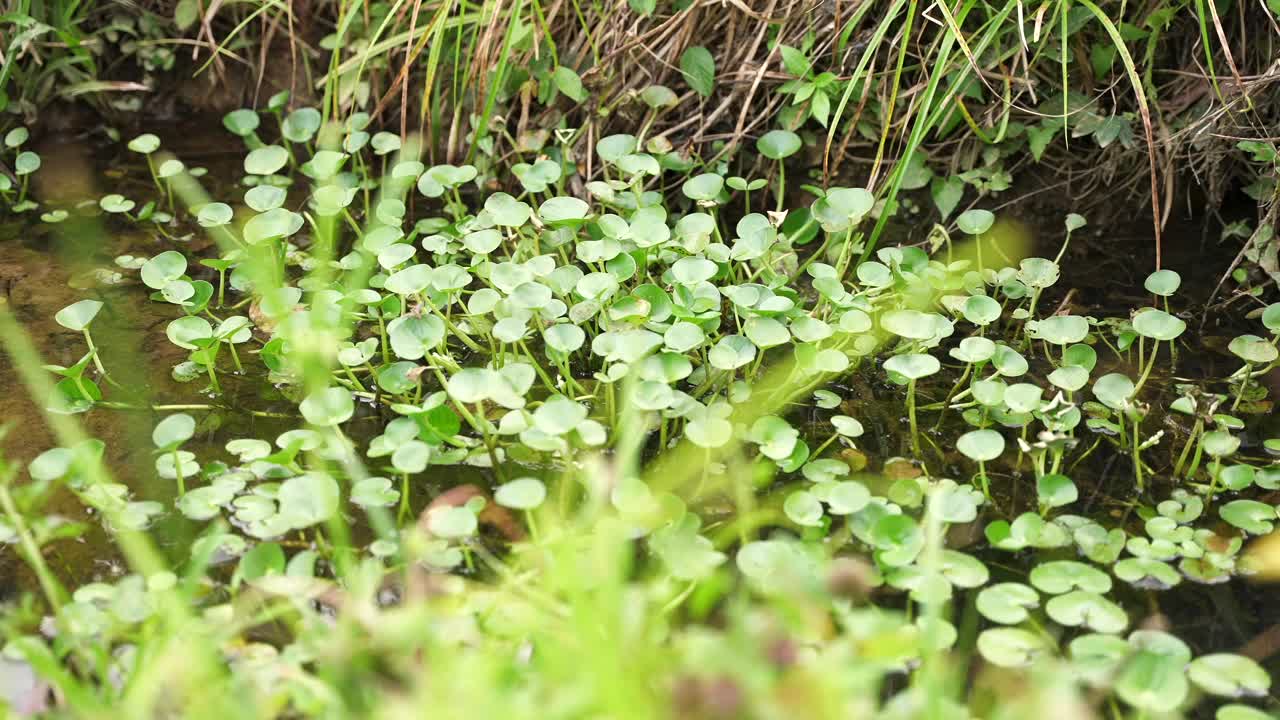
top-left (10, 0), bottom-right (1280, 219)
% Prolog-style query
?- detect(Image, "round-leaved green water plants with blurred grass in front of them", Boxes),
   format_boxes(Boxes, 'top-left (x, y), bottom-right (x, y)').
top-left (0, 109), bottom-right (1280, 717)
